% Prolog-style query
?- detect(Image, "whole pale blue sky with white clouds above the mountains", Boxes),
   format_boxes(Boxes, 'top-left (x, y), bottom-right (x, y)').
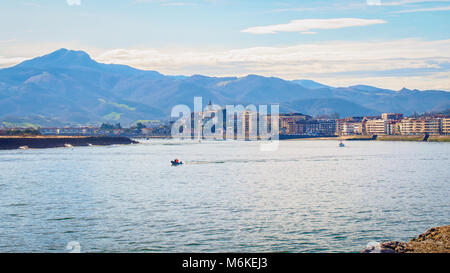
top-left (0, 0), bottom-right (450, 91)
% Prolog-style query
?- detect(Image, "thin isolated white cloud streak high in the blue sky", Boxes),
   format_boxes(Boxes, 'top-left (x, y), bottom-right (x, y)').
top-left (241, 18), bottom-right (387, 34)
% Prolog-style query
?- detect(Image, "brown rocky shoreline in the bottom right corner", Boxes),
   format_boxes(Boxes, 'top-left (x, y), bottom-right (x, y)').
top-left (362, 225), bottom-right (450, 253)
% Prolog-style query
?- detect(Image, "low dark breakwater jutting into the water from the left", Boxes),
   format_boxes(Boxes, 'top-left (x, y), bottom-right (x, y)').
top-left (0, 136), bottom-right (136, 150)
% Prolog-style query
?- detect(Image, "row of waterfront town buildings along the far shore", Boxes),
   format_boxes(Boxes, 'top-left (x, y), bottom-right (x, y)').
top-left (33, 111), bottom-right (450, 140)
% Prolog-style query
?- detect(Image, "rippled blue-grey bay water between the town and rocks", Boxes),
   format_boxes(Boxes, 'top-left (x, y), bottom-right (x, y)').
top-left (0, 140), bottom-right (450, 252)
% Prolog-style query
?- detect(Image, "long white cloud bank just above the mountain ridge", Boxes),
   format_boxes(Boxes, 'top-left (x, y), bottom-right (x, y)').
top-left (94, 39), bottom-right (450, 90)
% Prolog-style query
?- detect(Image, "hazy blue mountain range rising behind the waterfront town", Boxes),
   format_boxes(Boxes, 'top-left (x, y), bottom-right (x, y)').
top-left (0, 49), bottom-right (450, 127)
